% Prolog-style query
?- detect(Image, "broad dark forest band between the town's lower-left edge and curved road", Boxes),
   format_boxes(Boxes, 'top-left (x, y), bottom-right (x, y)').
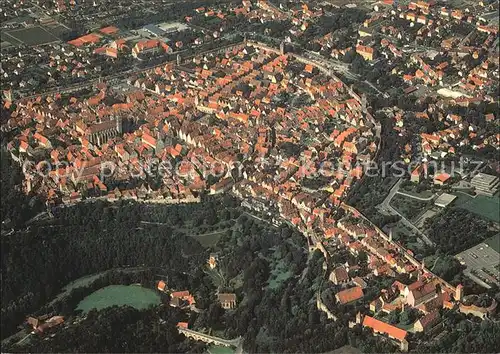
top-left (1, 198), bottom-right (206, 336)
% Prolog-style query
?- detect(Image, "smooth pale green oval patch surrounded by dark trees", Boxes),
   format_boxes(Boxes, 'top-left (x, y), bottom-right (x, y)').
top-left (76, 285), bottom-right (161, 313)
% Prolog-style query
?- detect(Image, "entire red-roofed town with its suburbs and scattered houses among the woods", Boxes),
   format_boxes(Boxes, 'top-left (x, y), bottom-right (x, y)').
top-left (0, 0), bottom-right (500, 352)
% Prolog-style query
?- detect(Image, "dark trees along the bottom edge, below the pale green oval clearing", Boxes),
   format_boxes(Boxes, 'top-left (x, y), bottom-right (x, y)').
top-left (10, 306), bottom-right (205, 353)
